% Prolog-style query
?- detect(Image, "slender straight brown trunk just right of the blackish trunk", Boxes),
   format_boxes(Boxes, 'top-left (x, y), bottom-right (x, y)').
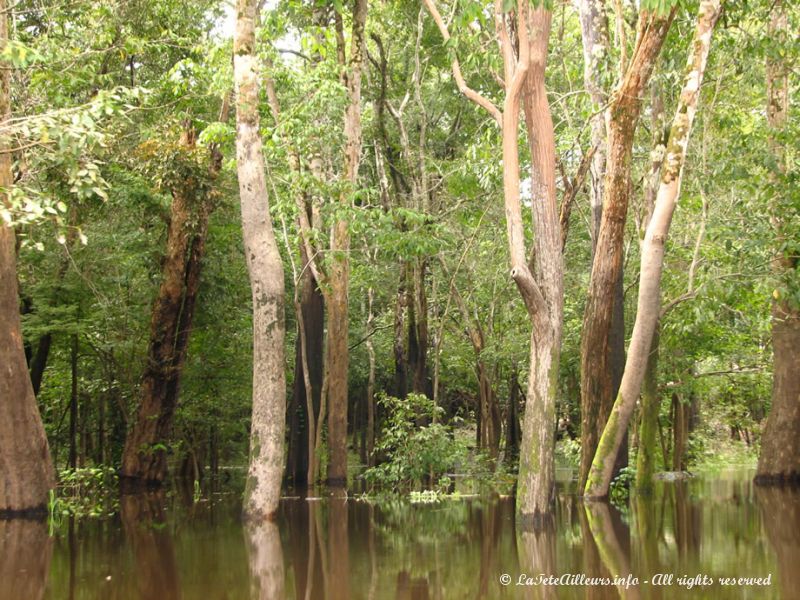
top-left (327, 0), bottom-right (367, 487)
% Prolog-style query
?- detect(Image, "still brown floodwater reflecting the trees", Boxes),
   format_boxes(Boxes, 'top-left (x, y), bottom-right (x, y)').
top-left (0, 471), bottom-right (800, 600)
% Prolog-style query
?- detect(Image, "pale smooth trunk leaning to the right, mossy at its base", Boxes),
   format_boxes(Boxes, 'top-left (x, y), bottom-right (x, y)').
top-left (582, 0), bottom-right (721, 497)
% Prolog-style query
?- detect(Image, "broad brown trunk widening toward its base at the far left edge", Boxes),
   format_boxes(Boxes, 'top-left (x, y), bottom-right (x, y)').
top-left (0, 0), bottom-right (54, 517)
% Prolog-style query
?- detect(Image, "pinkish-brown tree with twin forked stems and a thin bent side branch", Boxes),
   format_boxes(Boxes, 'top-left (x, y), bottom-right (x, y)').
top-left (425, 0), bottom-right (564, 527)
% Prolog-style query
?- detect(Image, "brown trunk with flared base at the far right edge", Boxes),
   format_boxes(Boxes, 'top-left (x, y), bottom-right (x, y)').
top-left (756, 0), bottom-right (800, 483)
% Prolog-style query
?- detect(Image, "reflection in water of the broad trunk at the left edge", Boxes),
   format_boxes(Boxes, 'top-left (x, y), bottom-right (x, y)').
top-left (0, 519), bottom-right (53, 600)
